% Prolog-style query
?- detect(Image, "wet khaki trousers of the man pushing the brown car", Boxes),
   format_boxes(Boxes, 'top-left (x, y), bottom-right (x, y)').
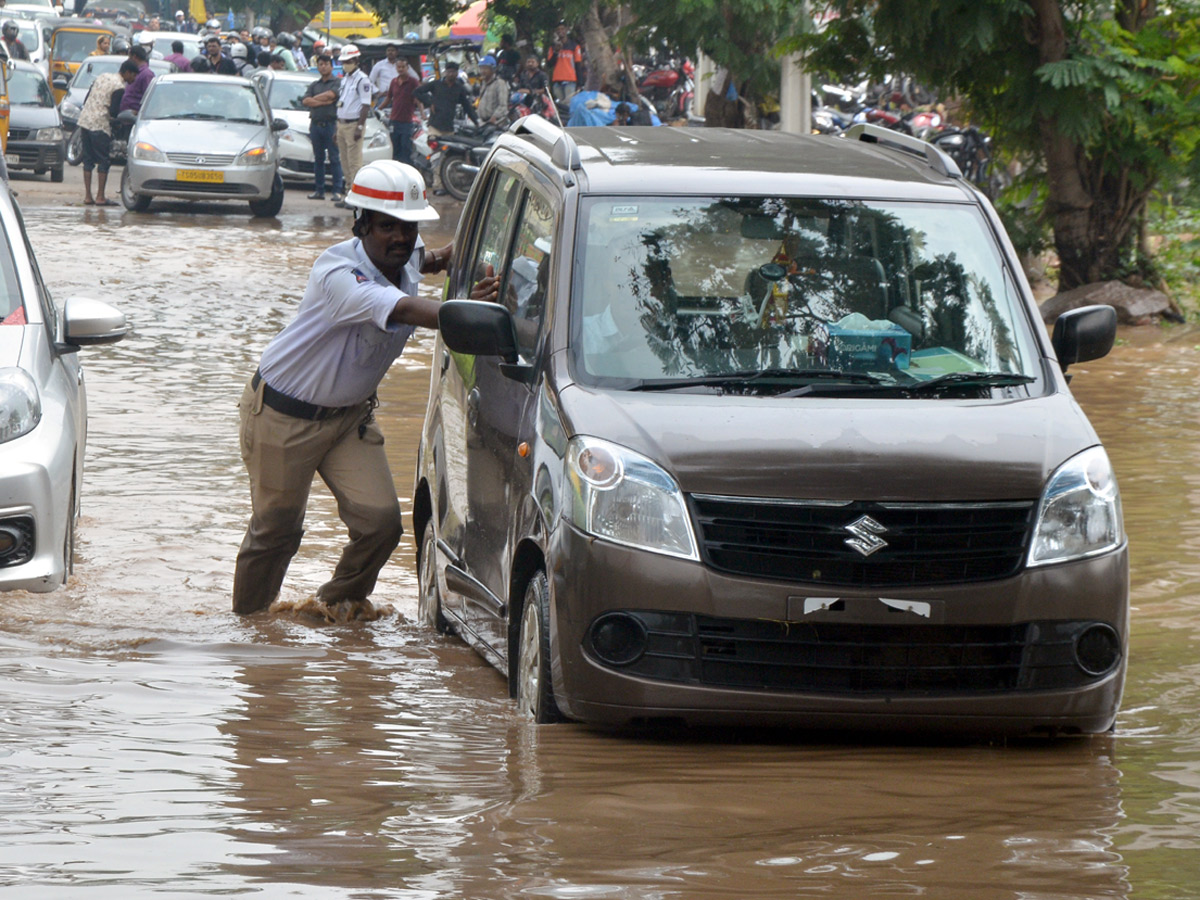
top-left (233, 383), bottom-right (404, 614)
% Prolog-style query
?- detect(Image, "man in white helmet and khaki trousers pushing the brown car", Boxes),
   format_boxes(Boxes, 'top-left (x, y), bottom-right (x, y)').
top-left (233, 160), bottom-right (497, 619)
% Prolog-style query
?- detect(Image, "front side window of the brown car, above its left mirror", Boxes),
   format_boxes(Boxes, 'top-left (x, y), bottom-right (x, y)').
top-left (500, 191), bottom-right (554, 358)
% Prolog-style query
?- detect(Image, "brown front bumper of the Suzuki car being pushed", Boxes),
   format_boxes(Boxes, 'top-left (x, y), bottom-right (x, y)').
top-left (548, 523), bottom-right (1129, 733)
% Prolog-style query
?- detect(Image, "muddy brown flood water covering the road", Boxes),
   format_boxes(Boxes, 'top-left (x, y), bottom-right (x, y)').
top-left (0, 208), bottom-right (1200, 900)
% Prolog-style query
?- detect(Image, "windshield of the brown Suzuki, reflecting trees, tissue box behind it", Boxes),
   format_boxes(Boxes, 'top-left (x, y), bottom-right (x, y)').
top-left (571, 197), bottom-right (1037, 391)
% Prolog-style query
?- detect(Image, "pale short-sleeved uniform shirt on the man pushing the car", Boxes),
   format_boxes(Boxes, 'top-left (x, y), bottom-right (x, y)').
top-left (258, 238), bottom-right (425, 407)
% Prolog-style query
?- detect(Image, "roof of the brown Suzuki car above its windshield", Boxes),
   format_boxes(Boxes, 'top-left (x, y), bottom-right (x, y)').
top-left (516, 126), bottom-right (967, 202)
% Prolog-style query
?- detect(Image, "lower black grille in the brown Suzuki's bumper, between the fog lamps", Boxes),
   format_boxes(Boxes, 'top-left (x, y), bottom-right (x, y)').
top-left (586, 611), bottom-right (1120, 696)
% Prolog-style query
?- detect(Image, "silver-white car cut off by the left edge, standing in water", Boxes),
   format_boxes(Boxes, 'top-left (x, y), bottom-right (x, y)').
top-left (0, 191), bottom-right (126, 590)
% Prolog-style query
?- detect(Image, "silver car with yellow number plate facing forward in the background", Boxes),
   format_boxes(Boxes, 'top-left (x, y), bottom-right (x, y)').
top-left (121, 73), bottom-right (288, 216)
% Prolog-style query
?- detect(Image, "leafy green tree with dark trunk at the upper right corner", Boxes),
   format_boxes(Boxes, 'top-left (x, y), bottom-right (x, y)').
top-left (792, 0), bottom-right (1200, 289)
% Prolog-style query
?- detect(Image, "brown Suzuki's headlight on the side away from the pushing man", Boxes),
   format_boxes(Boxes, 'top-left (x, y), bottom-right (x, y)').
top-left (1030, 446), bottom-right (1124, 565)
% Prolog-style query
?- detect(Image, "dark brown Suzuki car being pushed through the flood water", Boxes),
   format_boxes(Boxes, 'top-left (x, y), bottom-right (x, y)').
top-left (414, 120), bottom-right (1129, 732)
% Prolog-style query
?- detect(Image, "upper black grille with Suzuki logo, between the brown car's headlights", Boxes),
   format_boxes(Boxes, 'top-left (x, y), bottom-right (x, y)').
top-left (689, 494), bottom-right (1037, 589)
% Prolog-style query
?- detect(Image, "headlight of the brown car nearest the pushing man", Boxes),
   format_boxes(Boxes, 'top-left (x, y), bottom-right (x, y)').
top-left (565, 437), bottom-right (700, 559)
